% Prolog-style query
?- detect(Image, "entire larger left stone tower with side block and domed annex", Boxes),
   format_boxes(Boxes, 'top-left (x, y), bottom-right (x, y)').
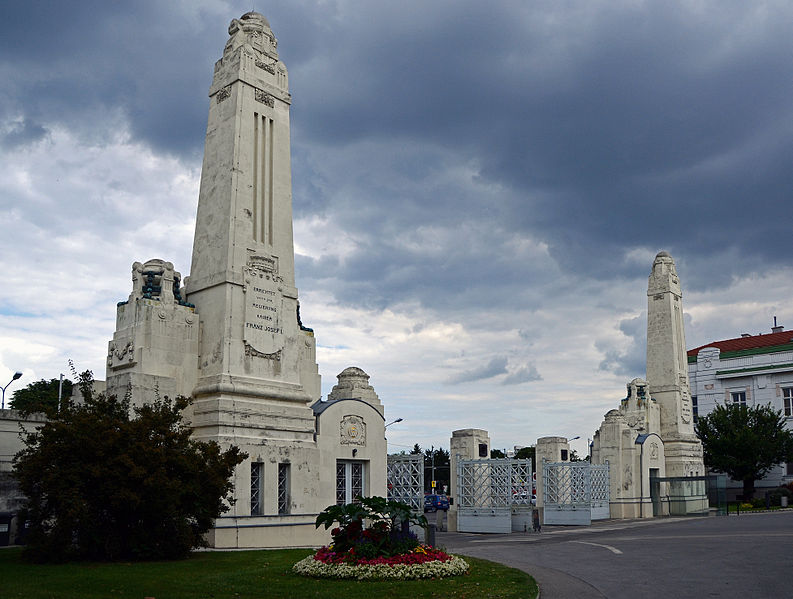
top-left (107, 12), bottom-right (387, 547)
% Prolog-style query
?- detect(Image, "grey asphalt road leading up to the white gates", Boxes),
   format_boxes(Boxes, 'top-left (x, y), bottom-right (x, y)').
top-left (438, 511), bottom-right (793, 599)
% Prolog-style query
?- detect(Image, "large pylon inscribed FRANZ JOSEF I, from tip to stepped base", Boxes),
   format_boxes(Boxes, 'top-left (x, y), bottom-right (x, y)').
top-left (185, 12), bottom-right (320, 468)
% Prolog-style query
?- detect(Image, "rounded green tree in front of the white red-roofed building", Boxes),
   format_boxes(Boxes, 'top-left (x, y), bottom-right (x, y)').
top-left (696, 403), bottom-right (793, 500)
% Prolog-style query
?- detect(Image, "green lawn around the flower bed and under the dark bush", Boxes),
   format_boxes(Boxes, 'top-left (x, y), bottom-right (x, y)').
top-left (0, 548), bottom-right (537, 599)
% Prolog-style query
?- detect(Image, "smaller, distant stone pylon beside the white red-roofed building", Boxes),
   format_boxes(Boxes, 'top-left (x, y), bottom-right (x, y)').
top-left (647, 252), bottom-right (705, 476)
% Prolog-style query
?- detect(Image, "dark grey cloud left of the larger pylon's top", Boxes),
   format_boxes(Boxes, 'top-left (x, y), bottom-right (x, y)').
top-left (0, 1), bottom-right (225, 154)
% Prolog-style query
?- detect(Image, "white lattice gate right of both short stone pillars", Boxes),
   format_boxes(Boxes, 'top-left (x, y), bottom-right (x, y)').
top-left (542, 462), bottom-right (609, 525)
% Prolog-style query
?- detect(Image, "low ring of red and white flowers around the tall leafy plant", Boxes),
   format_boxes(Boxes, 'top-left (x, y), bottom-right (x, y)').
top-left (292, 545), bottom-right (468, 580)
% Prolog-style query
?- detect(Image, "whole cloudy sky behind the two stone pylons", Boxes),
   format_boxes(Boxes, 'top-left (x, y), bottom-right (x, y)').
top-left (0, 0), bottom-right (793, 460)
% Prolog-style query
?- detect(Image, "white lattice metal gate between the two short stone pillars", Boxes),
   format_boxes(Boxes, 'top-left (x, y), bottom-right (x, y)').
top-left (457, 459), bottom-right (532, 533)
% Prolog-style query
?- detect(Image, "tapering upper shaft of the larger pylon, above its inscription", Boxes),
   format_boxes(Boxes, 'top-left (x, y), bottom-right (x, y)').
top-left (189, 12), bottom-right (294, 292)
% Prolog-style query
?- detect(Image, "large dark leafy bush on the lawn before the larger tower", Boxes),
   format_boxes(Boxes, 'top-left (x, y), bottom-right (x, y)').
top-left (14, 372), bottom-right (247, 561)
